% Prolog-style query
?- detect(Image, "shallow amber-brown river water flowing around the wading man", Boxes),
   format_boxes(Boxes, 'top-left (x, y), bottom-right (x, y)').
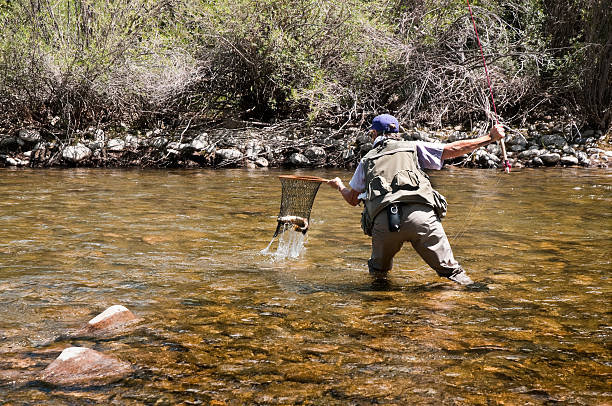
top-left (0, 169), bottom-right (612, 405)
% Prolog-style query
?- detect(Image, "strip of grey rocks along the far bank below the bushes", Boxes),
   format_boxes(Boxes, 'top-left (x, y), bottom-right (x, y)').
top-left (0, 122), bottom-right (612, 168)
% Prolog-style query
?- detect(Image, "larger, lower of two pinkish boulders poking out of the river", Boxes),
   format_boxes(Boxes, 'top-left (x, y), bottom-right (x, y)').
top-left (40, 347), bottom-right (132, 386)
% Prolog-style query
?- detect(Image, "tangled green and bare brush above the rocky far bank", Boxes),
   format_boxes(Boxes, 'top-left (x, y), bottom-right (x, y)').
top-left (0, 0), bottom-right (612, 134)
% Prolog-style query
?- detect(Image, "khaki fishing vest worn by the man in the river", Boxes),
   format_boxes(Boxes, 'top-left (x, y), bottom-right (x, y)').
top-left (361, 140), bottom-right (447, 236)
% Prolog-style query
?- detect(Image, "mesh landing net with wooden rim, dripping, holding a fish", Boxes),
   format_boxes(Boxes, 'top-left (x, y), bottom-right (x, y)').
top-left (274, 175), bottom-right (327, 237)
